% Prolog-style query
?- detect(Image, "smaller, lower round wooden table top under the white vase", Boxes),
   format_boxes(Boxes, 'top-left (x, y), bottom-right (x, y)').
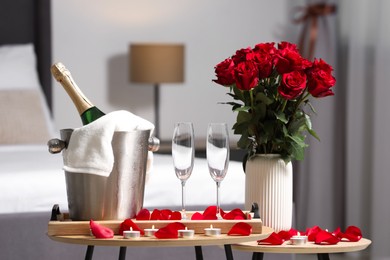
top-left (232, 238), bottom-right (371, 254)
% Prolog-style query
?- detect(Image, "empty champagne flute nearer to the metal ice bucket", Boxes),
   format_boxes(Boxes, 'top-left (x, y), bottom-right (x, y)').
top-left (172, 122), bottom-right (195, 219)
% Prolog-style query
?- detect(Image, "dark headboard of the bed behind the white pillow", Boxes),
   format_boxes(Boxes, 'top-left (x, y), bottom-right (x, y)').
top-left (0, 0), bottom-right (52, 110)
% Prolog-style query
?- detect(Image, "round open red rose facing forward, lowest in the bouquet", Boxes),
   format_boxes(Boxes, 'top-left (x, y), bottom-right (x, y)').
top-left (278, 71), bottom-right (306, 100)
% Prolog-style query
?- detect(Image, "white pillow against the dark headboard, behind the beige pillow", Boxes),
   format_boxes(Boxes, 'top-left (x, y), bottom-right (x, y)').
top-left (0, 43), bottom-right (40, 90)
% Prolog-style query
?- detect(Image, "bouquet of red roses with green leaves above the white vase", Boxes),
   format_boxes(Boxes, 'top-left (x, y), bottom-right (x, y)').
top-left (213, 42), bottom-right (336, 161)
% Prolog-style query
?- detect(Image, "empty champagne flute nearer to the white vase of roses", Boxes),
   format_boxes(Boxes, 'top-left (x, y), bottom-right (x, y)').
top-left (206, 123), bottom-right (230, 219)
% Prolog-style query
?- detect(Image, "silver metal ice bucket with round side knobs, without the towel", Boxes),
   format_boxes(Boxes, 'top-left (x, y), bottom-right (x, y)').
top-left (49, 129), bottom-right (159, 220)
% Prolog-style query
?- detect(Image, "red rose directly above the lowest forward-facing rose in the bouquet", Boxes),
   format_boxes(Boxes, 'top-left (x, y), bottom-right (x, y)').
top-left (275, 47), bottom-right (312, 74)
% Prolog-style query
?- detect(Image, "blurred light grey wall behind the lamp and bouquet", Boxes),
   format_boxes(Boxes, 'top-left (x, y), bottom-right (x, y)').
top-left (52, 0), bottom-right (302, 140)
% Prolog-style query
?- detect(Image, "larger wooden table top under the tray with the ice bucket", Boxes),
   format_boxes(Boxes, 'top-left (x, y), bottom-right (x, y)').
top-left (48, 226), bottom-right (273, 247)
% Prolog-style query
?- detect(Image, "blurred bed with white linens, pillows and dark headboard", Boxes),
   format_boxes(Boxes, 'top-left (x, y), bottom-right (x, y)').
top-left (0, 0), bottom-right (249, 259)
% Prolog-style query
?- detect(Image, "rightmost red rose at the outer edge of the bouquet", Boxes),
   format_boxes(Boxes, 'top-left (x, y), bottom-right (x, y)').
top-left (307, 59), bottom-right (336, 97)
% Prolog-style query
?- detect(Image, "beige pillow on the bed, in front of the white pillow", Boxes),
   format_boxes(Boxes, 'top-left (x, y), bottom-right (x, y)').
top-left (0, 89), bottom-right (51, 145)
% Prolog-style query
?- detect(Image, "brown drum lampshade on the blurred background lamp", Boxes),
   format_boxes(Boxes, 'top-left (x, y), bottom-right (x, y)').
top-left (129, 43), bottom-right (184, 84)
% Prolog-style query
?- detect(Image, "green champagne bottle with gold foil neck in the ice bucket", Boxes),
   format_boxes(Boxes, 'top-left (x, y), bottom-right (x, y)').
top-left (51, 62), bottom-right (105, 125)
